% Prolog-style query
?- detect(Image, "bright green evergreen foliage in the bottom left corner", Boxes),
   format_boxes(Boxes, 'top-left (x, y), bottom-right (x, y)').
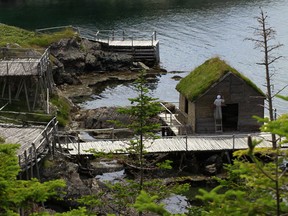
top-left (0, 144), bottom-right (65, 215)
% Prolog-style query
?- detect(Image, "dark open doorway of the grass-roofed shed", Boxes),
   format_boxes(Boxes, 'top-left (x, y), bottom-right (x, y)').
top-left (222, 104), bottom-right (238, 132)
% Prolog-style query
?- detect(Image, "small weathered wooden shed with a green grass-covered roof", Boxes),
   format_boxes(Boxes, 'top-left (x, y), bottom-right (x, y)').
top-left (176, 57), bottom-right (265, 133)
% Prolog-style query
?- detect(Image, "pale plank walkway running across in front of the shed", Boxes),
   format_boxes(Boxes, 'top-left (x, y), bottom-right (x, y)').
top-left (62, 133), bottom-right (272, 155)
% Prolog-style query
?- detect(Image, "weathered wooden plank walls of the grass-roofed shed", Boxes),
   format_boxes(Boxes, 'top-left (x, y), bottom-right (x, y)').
top-left (179, 73), bottom-right (264, 133)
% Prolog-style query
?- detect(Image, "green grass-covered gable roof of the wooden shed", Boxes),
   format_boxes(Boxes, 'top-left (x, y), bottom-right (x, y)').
top-left (176, 57), bottom-right (264, 101)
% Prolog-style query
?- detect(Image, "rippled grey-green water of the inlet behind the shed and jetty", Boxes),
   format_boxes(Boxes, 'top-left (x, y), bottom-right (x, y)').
top-left (0, 0), bottom-right (288, 113)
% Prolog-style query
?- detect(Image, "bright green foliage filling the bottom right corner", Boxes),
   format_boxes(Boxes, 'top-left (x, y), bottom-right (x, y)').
top-left (197, 156), bottom-right (288, 215)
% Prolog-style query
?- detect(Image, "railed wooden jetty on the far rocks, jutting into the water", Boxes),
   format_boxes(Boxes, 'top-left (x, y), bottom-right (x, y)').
top-left (36, 26), bottom-right (160, 65)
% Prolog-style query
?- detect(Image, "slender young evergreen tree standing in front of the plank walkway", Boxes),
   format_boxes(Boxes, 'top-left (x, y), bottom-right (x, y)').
top-left (118, 70), bottom-right (162, 191)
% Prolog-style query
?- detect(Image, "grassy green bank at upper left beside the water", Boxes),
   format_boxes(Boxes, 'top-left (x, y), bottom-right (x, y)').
top-left (0, 24), bottom-right (75, 48)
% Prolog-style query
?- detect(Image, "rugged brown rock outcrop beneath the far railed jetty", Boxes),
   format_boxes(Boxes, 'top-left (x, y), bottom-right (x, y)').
top-left (50, 38), bottom-right (135, 85)
